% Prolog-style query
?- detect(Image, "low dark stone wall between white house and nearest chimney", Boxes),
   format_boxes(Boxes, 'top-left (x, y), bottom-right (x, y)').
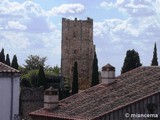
top-left (20, 87), bottom-right (44, 119)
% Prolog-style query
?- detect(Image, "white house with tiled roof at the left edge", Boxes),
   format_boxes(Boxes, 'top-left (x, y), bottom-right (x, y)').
top-left (0, 62), bottom-right (20, 120)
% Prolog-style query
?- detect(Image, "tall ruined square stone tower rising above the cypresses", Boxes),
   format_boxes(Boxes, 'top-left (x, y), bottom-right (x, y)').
top-left (61, 18), bottom-right (95, 89)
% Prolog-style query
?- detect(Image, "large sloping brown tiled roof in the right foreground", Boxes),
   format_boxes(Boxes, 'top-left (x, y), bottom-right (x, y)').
top-left (30, 67), bottom-right (160, 120)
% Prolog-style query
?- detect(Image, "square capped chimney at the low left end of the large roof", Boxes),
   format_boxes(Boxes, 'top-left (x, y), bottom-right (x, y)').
top-left (44, 87), bottom-right (58, 110)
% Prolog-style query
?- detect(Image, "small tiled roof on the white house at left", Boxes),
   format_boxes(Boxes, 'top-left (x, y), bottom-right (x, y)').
top-left (0, 62), bottom-right (19, 73)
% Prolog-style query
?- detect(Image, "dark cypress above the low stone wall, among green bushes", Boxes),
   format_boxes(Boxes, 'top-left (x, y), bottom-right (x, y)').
top-left (38, 66), bottom-right (46, 86)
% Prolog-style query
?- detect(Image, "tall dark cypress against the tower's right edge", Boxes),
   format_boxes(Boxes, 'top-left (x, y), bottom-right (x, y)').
top-left (91, 52), bottom-right (99, 87)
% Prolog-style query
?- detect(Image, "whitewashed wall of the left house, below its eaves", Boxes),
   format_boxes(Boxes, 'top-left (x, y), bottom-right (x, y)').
top-left (0, 77), bottom-right (20, 120)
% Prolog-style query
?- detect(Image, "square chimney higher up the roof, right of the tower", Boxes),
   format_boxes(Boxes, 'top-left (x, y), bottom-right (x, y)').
top-left (101, 64), bottom-right (115, 84)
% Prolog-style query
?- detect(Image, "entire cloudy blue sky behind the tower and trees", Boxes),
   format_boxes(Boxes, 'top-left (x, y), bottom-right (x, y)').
top-left (0, 0), bottom-right (160, 75)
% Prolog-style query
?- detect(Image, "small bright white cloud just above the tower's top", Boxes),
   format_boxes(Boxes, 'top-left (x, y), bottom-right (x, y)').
top-left (48, 3), bottom-right (85, 16)
